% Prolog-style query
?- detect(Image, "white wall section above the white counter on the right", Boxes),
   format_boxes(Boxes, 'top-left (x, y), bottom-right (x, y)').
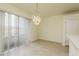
top-left (65, 12), bottom-right (79, 34)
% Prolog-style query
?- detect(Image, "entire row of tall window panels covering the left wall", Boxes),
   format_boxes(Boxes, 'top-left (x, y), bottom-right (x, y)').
top-left (0, 11), bottom-right (31, 55)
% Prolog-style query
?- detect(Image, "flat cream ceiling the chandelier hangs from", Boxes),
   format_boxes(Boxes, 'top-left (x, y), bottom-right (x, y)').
top-left (11, 3), bottom-right (79, 17)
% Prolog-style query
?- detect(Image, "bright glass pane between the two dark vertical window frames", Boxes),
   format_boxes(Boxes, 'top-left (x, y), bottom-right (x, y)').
top-left (9, 14), bottom-right (18, 48)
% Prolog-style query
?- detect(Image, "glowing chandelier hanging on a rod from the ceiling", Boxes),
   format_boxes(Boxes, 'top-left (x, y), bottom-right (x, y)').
top-left (33, 3), bottom-right (41, 25)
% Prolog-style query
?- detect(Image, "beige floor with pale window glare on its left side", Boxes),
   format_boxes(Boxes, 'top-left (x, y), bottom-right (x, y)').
top-left (4, 40), bottom-right (69, 56)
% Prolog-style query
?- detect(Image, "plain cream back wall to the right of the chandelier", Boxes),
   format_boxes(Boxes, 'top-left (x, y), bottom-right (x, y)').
top-left (38, 15), bottom-right (64, 42)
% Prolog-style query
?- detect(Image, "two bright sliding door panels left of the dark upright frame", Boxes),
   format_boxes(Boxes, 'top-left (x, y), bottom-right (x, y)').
top-left (4, 13), bottom-right (19, 54)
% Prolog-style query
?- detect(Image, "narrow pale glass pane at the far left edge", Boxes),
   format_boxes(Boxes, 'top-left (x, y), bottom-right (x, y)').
top-left (0, 12), bottom-right (5, 55)
